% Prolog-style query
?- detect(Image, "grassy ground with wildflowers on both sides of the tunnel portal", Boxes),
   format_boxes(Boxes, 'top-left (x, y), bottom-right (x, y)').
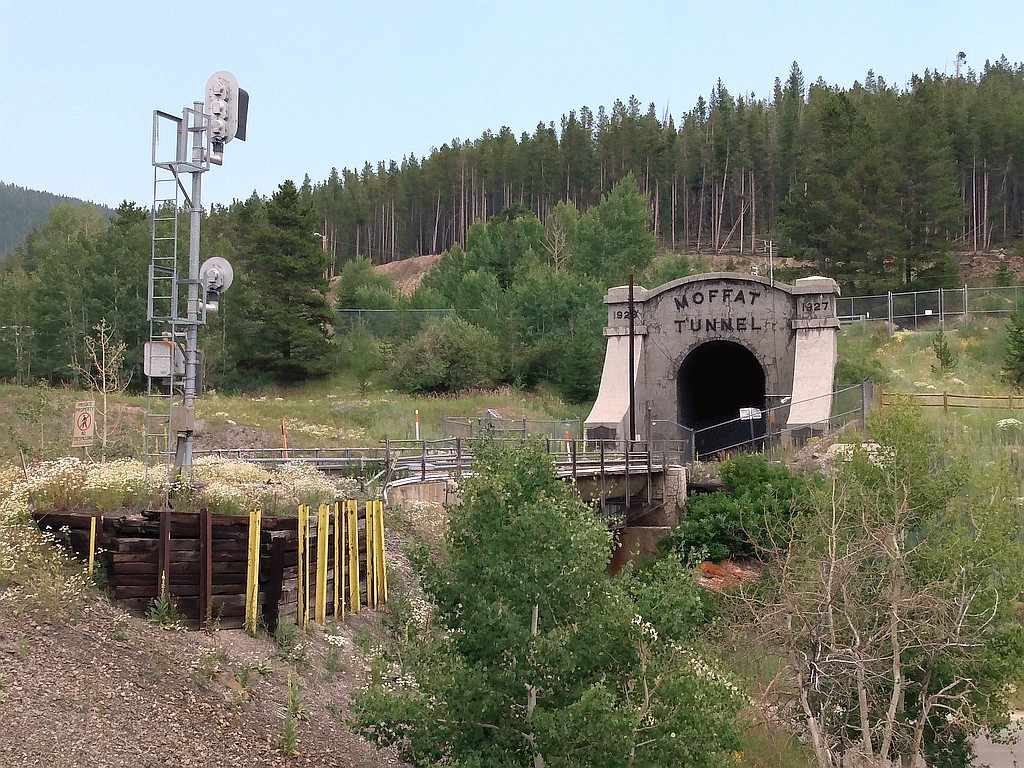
top-left (0, 322), bottom-right (1024, 461)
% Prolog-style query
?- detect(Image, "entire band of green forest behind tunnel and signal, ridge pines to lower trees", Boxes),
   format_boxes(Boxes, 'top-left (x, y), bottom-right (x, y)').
top-left (0, 54), bottom-right (1024, 402)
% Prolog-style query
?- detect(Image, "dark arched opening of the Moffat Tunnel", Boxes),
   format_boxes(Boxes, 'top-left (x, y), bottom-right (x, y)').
top-left (677, 340), bottom-right (766, 457)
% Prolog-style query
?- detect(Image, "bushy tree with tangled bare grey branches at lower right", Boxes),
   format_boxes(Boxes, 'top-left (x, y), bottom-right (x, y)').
top-left (736, 415), bottom-right (1024, 768)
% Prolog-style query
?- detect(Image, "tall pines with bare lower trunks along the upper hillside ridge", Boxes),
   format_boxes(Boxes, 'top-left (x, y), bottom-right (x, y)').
top-left (303, 57), bottom-right (1024, 294)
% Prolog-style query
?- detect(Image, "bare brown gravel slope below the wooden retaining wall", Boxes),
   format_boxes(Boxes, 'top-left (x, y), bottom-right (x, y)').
top-left (0, 573), bottom-right (401, 768)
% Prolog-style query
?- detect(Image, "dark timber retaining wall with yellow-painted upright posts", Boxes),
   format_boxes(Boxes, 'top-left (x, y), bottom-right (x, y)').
top-left (33, 501), bottom-right (387, 631)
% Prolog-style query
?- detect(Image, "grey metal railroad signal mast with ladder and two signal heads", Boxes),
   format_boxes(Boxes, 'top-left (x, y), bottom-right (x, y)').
top-left (143, 72), bottom-right (249, 481)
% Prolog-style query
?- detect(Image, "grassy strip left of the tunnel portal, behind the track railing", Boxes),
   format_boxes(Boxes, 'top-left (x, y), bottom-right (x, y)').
top-left (0, 381), bottom-right (587, 461)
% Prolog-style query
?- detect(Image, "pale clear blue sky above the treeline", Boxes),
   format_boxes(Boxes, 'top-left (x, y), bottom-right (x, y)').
top-left (0, 0), bottom-right (1024, 207)
